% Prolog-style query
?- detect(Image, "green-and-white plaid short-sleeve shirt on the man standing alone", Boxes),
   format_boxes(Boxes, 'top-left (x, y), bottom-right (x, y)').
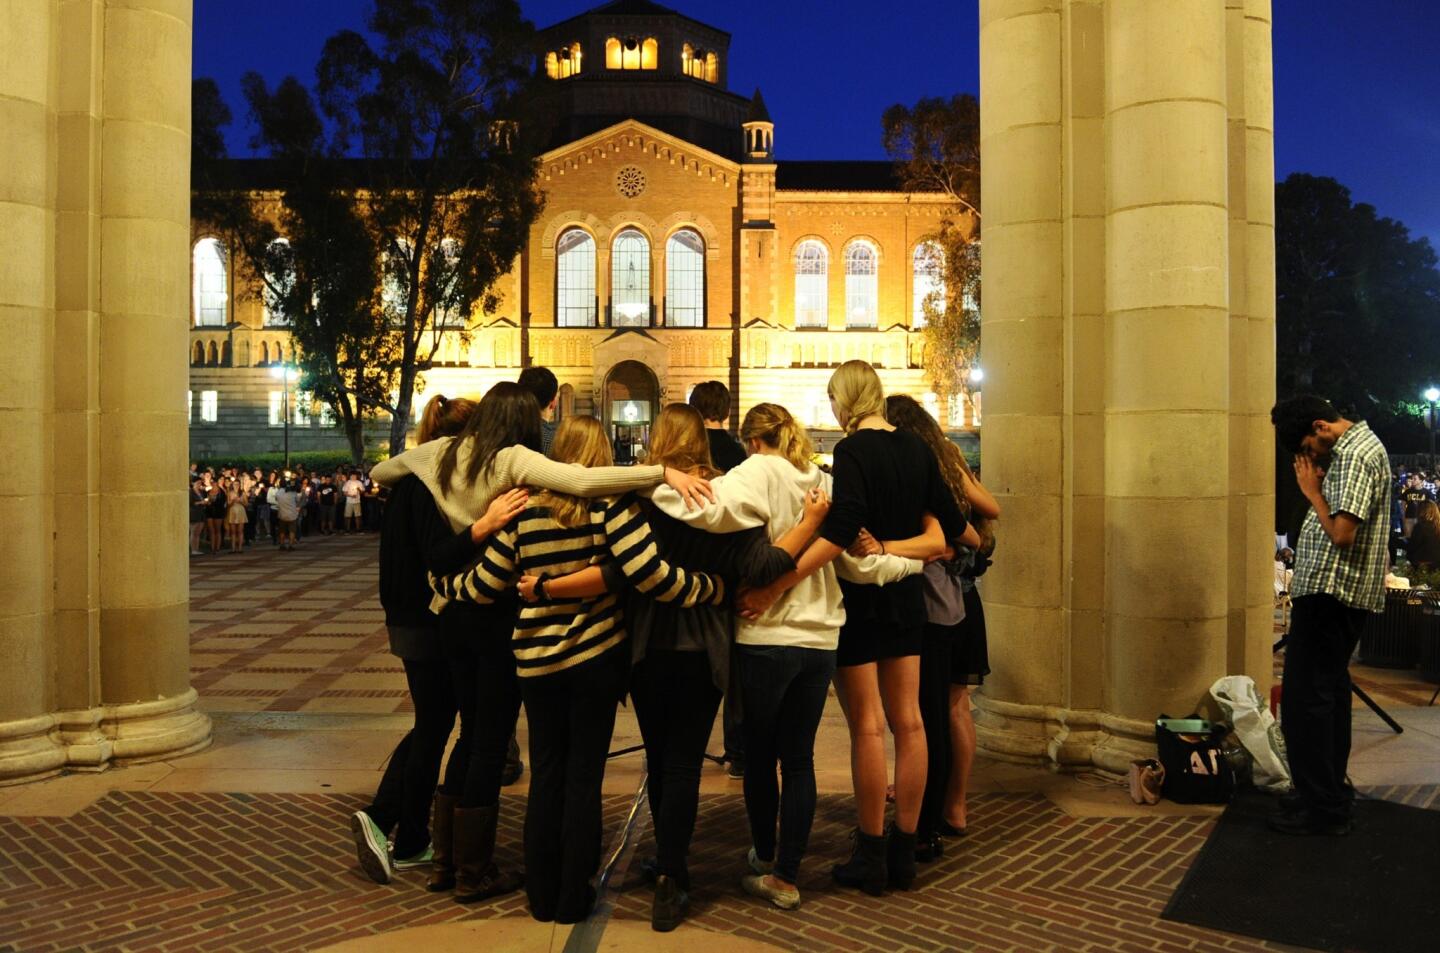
top-left (1290, 423), bottom-right (1390, 612)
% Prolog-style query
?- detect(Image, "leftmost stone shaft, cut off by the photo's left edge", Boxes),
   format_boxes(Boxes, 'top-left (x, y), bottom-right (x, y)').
top-left (0, 3), bottom-right (65, 782)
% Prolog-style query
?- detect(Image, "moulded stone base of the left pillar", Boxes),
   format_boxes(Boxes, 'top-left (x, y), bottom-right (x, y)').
top-left (0, 688), bottom-right (210, 786)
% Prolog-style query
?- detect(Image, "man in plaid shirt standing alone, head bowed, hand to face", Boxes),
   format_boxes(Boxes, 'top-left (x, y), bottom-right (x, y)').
top-left (1270, 396), bottom-right (1390, 835)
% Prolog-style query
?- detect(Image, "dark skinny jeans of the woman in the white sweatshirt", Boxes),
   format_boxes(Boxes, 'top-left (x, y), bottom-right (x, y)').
top-left (734, 645), bottom-right (835, 884)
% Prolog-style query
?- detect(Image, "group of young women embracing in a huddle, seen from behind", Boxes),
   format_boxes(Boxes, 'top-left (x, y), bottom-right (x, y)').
top-left (351, 361), bottom-right (999, 930)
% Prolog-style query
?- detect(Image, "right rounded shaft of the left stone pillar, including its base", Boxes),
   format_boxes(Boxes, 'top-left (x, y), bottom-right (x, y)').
top-left (99, 0), bottom-right (210, 760)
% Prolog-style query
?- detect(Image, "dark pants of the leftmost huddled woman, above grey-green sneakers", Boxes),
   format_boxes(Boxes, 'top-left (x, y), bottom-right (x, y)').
top-left (364, 659), bottom-right (455, 857)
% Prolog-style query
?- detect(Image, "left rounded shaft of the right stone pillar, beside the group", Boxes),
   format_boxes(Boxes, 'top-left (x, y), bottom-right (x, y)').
top-left (978, 0), bottom-right (1066, 759)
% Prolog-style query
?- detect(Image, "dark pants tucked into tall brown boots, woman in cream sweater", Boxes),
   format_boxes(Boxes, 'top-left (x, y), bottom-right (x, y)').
top-left (441, 605), bottom-right (520, 808)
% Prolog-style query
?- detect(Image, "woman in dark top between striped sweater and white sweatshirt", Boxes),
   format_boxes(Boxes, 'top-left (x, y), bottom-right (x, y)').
top-left (521, 403), bottom-right (829, 931)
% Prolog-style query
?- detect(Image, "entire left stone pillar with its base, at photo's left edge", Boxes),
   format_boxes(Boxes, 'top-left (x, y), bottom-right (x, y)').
top-left (0, 0), bottom-right (210, 783)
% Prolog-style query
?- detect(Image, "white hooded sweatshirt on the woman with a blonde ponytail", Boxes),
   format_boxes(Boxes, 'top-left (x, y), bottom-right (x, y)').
top-left (651, 453), bottom-right (924, 651)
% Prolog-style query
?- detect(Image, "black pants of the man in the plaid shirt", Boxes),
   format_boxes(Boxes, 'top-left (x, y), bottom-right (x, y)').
top-left (1280, 596), bottom-right (1369, 821)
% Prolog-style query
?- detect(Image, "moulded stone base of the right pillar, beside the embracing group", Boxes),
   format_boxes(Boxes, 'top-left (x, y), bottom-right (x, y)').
top-left (973, 692), bottom-right (1155, 774)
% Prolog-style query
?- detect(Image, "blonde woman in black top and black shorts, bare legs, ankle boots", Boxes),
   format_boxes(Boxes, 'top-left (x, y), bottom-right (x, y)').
top-left (742, 361), bottom-right (979, 895)
